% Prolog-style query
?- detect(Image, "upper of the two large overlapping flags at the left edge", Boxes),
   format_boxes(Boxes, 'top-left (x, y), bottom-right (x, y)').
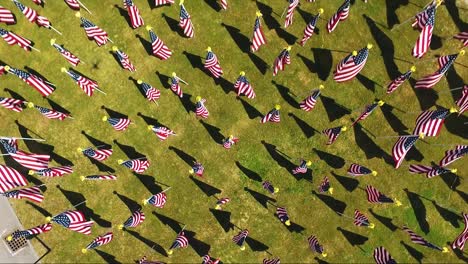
top-left (0, 139), bottom-right (50, 170)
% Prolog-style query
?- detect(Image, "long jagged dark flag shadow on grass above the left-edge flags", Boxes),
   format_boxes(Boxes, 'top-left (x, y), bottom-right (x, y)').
top-left (15, 120), bottom-right (73, 166)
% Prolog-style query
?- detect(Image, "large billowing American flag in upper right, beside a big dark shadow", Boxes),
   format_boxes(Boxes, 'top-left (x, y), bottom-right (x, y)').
top-left (333, 47), bottom-right (369, 83)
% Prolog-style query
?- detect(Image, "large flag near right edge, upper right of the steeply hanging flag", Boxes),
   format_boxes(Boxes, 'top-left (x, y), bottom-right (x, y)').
top-left (413, 108), bottom-right (451, 137)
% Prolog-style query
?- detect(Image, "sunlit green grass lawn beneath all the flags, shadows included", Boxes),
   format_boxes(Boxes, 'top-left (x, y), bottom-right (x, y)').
top-left (0, 0), bottom-right (468, 263)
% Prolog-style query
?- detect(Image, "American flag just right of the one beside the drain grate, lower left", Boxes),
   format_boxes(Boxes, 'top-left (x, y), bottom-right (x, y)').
top-left (50, 210), bottom-right (94, 235)
